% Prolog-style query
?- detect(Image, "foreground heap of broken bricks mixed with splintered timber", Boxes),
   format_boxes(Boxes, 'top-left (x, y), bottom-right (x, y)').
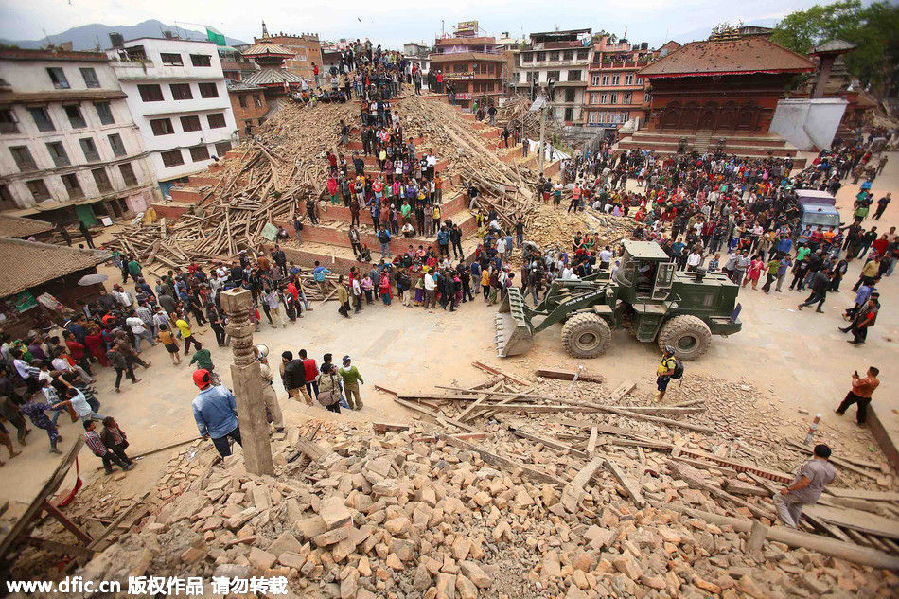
top-left (26, 373), bottom-right (899, 599)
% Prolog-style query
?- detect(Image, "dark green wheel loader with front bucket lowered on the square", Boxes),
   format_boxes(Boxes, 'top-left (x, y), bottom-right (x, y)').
top-left (496, 240), bottom-right (743, 360)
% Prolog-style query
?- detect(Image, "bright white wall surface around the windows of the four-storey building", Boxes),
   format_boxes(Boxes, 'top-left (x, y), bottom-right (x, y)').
top-left (108, 38), bottom-right (237, 181)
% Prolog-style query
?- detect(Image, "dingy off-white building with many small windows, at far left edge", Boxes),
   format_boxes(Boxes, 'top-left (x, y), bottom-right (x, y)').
top-left (0, 49), bottom-right (155, 225)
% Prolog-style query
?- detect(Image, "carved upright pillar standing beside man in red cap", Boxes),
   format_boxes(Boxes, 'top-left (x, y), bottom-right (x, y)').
top-left (221, 289), bottom-right (274, 474)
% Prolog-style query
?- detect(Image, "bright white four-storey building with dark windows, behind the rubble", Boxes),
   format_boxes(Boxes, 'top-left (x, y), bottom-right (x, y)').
top-left (108, 38), bottom-right (237, 194)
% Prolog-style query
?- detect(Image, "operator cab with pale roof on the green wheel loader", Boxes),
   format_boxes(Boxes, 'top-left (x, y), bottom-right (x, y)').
top-left (615, 240), bottom-right (677, 304)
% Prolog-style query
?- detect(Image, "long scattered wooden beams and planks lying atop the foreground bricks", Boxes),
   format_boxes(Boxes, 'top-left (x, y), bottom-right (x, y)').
top-left (381, 362), bottom-right (899, 559)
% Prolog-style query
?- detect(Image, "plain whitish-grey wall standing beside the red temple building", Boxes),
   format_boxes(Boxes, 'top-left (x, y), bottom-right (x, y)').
top-left (770, 98), bottom-right (849, 150)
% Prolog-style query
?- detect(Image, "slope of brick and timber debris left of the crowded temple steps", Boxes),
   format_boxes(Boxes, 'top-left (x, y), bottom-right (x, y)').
top-left (108, 103), bottom-right (355, 269)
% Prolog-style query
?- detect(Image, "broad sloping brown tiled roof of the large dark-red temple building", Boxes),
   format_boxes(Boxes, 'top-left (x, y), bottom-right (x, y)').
top-left (639, 37), bottom-right (815, 79)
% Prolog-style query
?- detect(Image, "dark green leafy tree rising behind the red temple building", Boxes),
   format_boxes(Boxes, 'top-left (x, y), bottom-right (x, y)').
top-left (771, 0), bottom-right (899, 97)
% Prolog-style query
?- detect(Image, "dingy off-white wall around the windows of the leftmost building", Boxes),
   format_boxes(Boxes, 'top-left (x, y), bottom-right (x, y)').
top-left (0, 54), bottom-right (155, 210)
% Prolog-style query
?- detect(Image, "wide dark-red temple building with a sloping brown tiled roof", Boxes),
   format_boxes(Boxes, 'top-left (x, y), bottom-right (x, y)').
top-left (637, 37), bottom-right (815, 134)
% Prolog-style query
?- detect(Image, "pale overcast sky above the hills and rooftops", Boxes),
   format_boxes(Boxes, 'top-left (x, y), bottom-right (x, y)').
top-left (0, 0), bottom-right (836, 48)
